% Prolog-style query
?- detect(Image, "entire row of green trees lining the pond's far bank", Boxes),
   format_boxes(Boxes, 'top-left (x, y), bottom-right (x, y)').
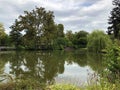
top-left (0, 4), bottom-right (118, 52)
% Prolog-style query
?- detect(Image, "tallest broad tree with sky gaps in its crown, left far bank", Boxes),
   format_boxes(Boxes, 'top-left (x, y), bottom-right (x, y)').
top-left (10, 7), bottom-right (56, 49)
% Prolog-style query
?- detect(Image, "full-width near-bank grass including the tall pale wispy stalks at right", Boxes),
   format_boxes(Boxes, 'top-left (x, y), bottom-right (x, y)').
top-left (0, 74), bottom-right (120, 90)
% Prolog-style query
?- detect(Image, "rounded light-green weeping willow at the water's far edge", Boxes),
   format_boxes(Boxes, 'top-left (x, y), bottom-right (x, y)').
top-left (87, 30), bottom-right (112, 52)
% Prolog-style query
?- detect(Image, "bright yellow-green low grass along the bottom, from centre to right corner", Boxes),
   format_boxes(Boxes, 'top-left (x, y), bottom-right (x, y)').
top-left (45, 82), bottom-right (120, 90)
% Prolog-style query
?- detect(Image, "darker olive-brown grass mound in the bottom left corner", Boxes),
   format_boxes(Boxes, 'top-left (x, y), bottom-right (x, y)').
top-left (0, 79), bottom-right (45, 90)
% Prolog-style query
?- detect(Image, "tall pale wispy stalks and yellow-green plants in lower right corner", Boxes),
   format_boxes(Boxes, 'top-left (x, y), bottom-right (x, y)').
top-left (82, 73), bottom-right (120, 90)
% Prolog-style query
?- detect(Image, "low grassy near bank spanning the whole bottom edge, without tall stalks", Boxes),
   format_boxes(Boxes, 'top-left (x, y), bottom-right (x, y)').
top-left (0, 81), bottom-right (120, 90)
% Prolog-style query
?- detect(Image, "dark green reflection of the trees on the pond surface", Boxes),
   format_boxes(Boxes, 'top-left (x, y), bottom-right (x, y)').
top-left (0, 51), bottom-right (104, 84)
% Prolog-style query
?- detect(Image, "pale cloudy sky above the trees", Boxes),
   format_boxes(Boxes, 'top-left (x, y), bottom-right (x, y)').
top-left (0, 0), bottom-right (113, 33)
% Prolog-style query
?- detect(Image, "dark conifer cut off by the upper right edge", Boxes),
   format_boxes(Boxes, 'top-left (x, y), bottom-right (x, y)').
top-left (108, 0), bottom-right (120, 39)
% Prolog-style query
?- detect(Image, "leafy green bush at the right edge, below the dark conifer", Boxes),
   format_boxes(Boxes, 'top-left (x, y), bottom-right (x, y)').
top-left (105, 44), bottom-right (120, 83)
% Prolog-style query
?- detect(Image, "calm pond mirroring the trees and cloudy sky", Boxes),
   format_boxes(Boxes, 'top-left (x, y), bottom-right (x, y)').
top-left (0, 51), bottom-right (105, 85)
